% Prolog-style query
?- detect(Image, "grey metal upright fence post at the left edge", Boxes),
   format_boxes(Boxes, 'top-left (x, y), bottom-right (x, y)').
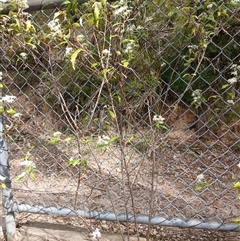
top-left (0, 115), bottom-right (16, 241)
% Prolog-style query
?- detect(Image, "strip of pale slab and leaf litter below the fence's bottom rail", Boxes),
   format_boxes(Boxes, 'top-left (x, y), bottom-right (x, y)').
top-left (12, 215), bottom-right (240, 241)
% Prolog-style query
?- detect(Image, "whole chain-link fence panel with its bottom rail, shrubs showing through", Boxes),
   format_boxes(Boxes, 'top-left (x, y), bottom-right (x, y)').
top-left (1, 0), bottom-right (240, 239)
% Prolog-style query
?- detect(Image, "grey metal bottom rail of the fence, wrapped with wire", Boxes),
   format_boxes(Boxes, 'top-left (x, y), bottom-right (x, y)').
top-left (9, 203), bottom-right (240, 232)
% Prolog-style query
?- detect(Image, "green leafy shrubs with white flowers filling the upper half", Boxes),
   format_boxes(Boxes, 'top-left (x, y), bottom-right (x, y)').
top-left (0, 0), bottom-right (240, 134)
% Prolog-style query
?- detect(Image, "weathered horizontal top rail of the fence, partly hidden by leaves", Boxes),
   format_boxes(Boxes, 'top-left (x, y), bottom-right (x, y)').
top-left (0, 0), bottom-right (86, 14)
